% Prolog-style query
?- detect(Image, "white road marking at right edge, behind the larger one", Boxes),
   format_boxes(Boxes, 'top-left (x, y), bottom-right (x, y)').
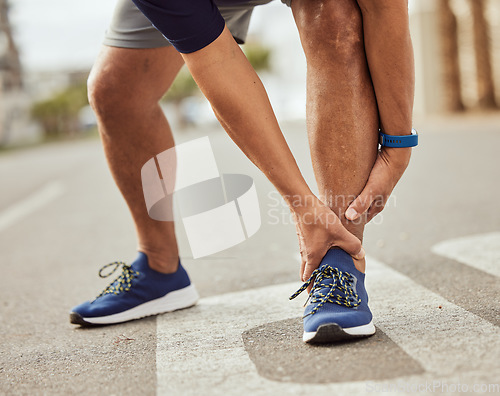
top-left (432, 232), bottom-right (500, 277)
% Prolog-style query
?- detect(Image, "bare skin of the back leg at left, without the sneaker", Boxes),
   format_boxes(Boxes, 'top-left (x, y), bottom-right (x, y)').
top-left (89, 47), bottom-right (183, 273)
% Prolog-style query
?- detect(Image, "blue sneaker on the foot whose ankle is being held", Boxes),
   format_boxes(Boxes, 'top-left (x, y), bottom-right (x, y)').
top-left (290, 249), bottom-right (375, 343)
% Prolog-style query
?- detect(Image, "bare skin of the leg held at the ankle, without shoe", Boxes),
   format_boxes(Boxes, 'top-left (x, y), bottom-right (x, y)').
top-left (292, 0), bottom-right (379, 272)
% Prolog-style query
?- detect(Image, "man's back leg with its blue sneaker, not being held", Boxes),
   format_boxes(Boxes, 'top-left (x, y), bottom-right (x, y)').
top-left (70, 47), bottom-right (199, 326)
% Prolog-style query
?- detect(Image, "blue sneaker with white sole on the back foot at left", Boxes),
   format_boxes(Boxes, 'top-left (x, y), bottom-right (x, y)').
top-left (69, 252), bottom-right (199, 326)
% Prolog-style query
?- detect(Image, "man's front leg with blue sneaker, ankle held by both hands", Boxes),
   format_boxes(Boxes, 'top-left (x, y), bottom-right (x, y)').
top-left (292, 0), bottom-right (379, 343)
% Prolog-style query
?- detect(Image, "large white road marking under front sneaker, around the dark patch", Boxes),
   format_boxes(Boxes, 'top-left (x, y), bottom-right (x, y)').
top-left (156, 255), bottom-right (500, 395)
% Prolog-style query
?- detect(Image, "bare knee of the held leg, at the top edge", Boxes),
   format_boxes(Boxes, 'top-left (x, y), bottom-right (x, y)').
top-left (292, 0), bottom-right (364, 62)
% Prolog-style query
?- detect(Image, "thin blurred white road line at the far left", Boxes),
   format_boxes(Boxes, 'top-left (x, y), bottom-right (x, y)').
top-left (0, 181), bottom-right (65, 232)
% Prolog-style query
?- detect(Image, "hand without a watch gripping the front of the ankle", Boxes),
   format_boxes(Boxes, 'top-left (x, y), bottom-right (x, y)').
top-left (292, 197), bottom-right (365, 282)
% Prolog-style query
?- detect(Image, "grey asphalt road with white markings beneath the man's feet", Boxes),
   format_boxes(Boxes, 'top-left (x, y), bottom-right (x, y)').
top-left (0, 117), bottom-right (500, 395)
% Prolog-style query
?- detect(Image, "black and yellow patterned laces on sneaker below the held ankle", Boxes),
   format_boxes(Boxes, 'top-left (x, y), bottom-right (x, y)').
top-left (290, 265), bottom-right (361, 316)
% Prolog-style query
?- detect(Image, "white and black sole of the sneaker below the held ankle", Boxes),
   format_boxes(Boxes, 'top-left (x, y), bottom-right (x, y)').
top-left (302, 322), bottom-right (375, 344)
